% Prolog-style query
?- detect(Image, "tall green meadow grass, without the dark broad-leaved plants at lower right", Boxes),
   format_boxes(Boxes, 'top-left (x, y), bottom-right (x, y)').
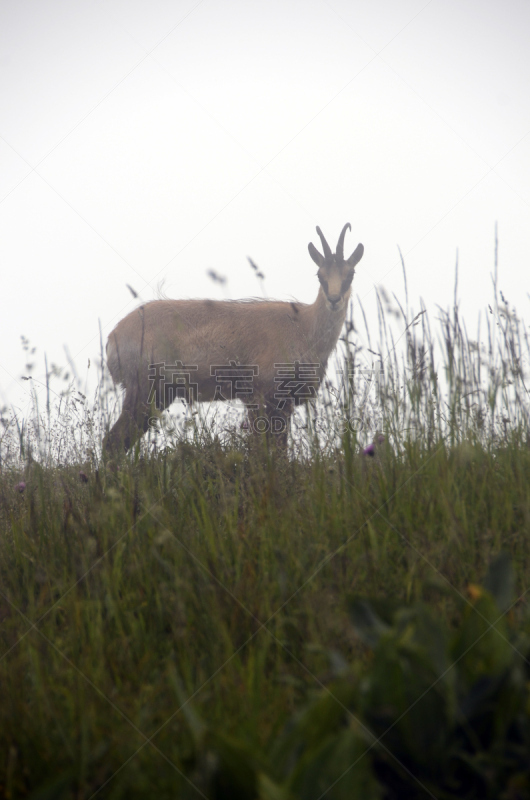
top-left (0, 252), bottom-right (530, 798)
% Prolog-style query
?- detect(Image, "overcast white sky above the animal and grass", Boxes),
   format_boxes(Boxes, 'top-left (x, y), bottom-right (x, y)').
top-left (0, 0), bottom-right (530, 408)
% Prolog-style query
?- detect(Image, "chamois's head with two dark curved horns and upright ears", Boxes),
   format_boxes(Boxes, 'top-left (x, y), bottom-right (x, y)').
top-left (308, 222), bottom-right (364, 311)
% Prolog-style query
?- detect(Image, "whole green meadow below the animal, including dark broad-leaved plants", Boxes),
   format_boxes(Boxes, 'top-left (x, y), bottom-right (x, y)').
top-left (0, 260), bottom-right (530, 800)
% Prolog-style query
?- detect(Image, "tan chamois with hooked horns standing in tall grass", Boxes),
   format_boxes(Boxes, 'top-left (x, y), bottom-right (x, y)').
top-left (104, 223), bottom-right (364, 451)
